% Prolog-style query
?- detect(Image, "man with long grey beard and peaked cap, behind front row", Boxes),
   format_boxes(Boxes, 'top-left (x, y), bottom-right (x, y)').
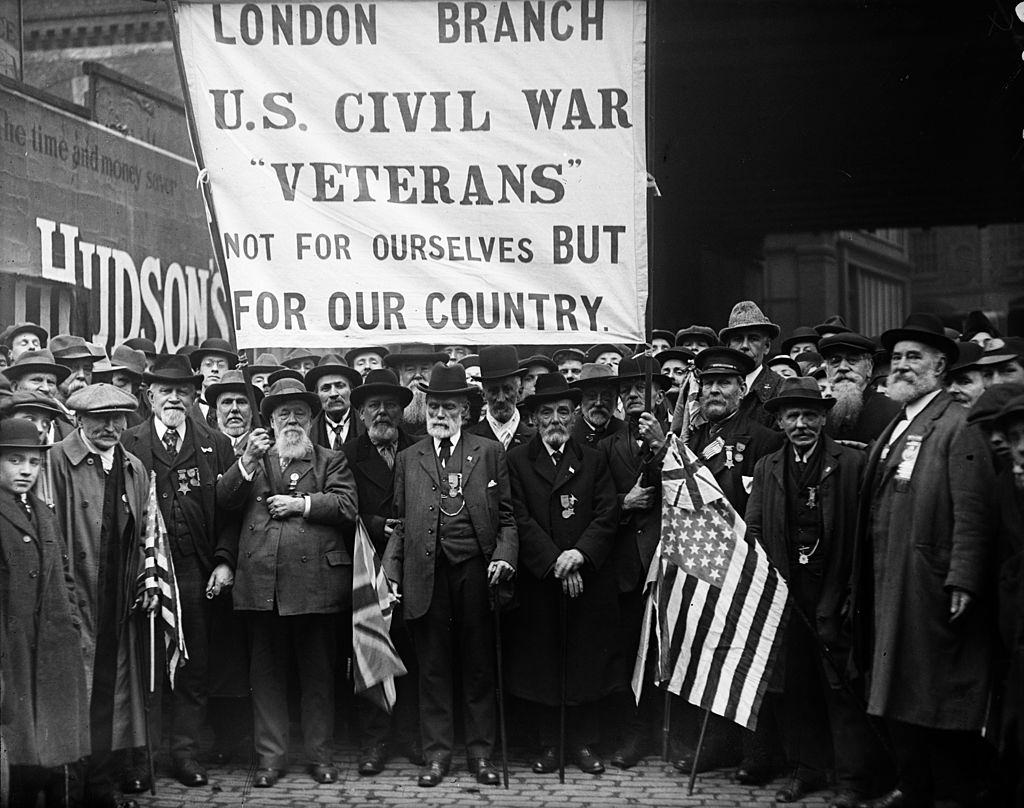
top-left (818, 331), bottom-right (899, 449)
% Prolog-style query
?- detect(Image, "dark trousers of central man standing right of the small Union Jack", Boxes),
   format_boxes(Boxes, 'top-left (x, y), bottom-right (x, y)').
top-left (410, 552), bottom-right (497, 762)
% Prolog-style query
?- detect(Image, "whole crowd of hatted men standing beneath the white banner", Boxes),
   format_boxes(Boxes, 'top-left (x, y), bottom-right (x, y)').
top-left (0, 301), bottom-right (1024, 808)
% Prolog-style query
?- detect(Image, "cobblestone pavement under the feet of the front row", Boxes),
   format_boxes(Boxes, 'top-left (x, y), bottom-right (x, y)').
top-left (137, 749), bottom-right (831, 808)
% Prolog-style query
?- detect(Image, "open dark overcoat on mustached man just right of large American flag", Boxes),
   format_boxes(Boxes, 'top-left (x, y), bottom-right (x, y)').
top-left (744, 436), bottom-right (864, 687)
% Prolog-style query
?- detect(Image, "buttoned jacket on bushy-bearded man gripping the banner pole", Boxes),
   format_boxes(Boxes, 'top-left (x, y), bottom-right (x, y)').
top-left (216, 445), bottom-right (357, 616)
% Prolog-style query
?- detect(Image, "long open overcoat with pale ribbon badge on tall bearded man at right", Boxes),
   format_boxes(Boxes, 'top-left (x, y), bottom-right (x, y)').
top-left (854, 391), bottom-right (993, 730)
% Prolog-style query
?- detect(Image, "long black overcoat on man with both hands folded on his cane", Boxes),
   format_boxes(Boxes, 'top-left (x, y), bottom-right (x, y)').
top-left (506, 436), bottom-right (625, 706)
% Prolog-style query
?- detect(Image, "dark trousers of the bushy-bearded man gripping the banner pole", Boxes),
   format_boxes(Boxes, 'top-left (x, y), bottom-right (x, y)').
top-left (247, 609), bottom-right (338, 770)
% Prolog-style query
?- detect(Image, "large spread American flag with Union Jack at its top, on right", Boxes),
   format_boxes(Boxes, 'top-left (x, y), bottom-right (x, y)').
top-left (633, 435), bottom-right (788, 729)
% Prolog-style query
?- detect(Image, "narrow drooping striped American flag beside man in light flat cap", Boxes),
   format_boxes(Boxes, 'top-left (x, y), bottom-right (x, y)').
top-left (138, 471), bottom-right (188, 688)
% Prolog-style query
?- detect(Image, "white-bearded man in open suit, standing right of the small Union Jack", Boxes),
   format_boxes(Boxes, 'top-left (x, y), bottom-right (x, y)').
top-left (383, 362), bottom-right (519, 786)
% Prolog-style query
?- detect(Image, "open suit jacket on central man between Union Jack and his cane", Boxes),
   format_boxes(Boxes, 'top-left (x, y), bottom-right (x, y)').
top-left (383, 431), bottom-right (519, 620)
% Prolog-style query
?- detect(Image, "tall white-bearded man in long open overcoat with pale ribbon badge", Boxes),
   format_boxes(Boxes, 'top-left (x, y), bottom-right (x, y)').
top-left (853, 314), bottom-right (992, 808)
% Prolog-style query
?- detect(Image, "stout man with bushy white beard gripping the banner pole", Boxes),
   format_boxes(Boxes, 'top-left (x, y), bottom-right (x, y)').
top-left (217, 378), bottom-right (357, 789)
